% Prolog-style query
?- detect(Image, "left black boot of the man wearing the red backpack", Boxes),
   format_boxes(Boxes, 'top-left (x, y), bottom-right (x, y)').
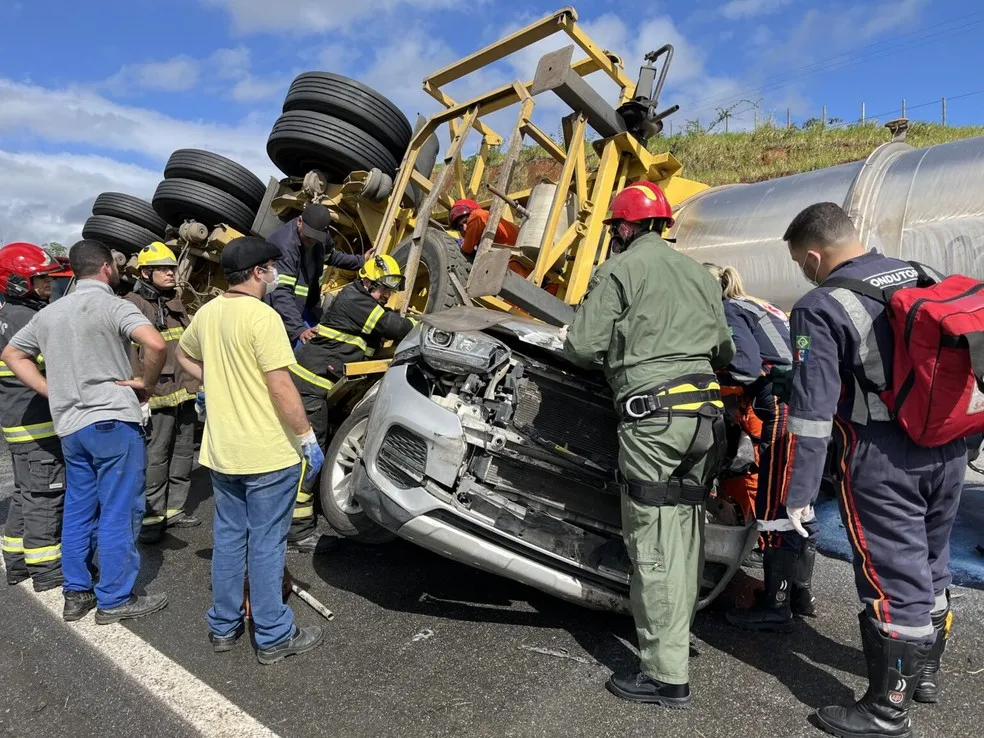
top-left (816, 612), bottom-right (930, 738)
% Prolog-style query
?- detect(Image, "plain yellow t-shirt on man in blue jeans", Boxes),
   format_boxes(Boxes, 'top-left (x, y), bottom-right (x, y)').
top-left (181, 296), bottom-right (301, 474)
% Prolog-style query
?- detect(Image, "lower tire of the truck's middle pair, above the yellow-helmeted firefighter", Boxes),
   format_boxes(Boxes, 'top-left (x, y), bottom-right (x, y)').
top-left (153, 179), bottom-right (256, 234)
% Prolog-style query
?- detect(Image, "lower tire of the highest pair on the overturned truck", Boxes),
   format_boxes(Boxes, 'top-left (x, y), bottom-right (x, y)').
top-left (267, 110), bottom-right (400, 184)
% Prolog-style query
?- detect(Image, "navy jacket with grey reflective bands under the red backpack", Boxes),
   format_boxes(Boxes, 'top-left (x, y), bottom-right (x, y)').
top-left (784, 249), bottom-right (938, 507)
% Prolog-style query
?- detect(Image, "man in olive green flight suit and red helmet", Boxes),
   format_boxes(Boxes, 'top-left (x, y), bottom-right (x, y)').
top-left (564, 182), bottom-right (734, 708)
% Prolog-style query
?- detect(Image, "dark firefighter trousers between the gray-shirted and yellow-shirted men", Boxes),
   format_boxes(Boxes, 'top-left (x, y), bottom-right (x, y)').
top-left (143, 400), bottom-right (198, 530)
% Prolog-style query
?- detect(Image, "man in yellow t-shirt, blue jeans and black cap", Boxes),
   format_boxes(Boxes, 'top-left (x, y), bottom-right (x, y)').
top-left (178, 237), bottom-right (324, 664)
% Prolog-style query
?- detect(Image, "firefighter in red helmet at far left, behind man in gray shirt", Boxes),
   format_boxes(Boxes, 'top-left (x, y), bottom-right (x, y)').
top-left (0, 243), bottom-right (65, 592)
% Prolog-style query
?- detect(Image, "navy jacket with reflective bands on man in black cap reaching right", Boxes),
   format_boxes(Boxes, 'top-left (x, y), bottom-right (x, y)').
top-left (263, 218), bottom-right (363, 344)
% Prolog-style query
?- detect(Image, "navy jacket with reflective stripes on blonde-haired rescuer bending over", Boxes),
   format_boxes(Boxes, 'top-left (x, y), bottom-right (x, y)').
top-left (721, 297), bottom-right (793, 385)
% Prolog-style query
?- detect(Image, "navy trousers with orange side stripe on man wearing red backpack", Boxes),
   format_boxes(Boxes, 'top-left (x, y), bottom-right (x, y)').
top-left (833, 418), bottom-right (967, 643)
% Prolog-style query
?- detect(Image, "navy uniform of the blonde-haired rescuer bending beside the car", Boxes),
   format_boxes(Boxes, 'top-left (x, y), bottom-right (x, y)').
top-left (722, 298), bottom-right (800, 550)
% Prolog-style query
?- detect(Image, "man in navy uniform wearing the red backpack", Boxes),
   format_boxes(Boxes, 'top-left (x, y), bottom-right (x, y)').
top-left (783, 202), bottom-right (967, 736)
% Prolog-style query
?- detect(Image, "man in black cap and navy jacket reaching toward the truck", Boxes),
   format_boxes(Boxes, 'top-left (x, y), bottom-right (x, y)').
top-left (263, 203), bottom-right (372, 346)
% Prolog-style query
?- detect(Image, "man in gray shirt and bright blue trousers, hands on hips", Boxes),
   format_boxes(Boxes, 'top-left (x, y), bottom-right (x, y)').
top-left (0, 240), bottom-right (167, 625)
